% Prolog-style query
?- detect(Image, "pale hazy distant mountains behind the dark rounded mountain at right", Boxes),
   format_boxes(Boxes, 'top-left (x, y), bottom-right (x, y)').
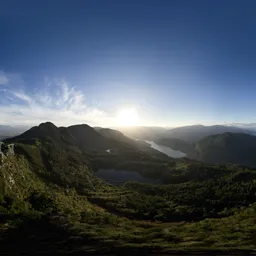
top-left (163, 125), bottom-right (251, 142)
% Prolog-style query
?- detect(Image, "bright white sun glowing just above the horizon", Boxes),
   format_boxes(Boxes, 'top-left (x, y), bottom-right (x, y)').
top-left (116, 108), bottom-right (139, 126)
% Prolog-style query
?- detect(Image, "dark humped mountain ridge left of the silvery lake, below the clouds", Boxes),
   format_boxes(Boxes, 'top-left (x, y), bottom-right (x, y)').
top-left (4, 122), bottom-right (171, 166)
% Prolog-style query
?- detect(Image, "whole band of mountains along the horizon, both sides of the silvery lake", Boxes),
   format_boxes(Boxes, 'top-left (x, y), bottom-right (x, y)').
top-left (0, 122), bottom-right (256, 167)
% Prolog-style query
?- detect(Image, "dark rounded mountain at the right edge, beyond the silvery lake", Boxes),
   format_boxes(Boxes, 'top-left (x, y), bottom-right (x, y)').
top-left (188, 133), bottom-right (256, 167)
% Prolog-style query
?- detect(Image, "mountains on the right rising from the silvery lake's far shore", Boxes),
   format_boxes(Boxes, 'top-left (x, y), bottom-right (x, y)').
top-left (155, 127), bottom-right (256, 168)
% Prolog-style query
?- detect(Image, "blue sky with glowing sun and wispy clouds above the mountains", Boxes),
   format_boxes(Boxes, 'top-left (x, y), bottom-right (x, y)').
top-left (0, 0), bottom-right (256, 127)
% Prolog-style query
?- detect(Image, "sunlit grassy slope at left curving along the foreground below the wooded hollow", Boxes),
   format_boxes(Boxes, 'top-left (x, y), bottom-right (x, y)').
top-left (0, 154), bottom-right (256, 255)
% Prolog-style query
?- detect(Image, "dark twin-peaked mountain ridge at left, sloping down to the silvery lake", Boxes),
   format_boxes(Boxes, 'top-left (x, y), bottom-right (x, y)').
top-left (4, 122), bottom-right (173, 175)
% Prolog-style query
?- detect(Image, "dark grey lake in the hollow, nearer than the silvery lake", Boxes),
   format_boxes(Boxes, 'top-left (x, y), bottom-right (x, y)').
top-left (95, 169), bottom-right (160, 185)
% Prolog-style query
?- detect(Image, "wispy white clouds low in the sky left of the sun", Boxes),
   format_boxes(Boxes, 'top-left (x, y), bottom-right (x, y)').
top-left (0, 77), bottom-right (116, 126)
